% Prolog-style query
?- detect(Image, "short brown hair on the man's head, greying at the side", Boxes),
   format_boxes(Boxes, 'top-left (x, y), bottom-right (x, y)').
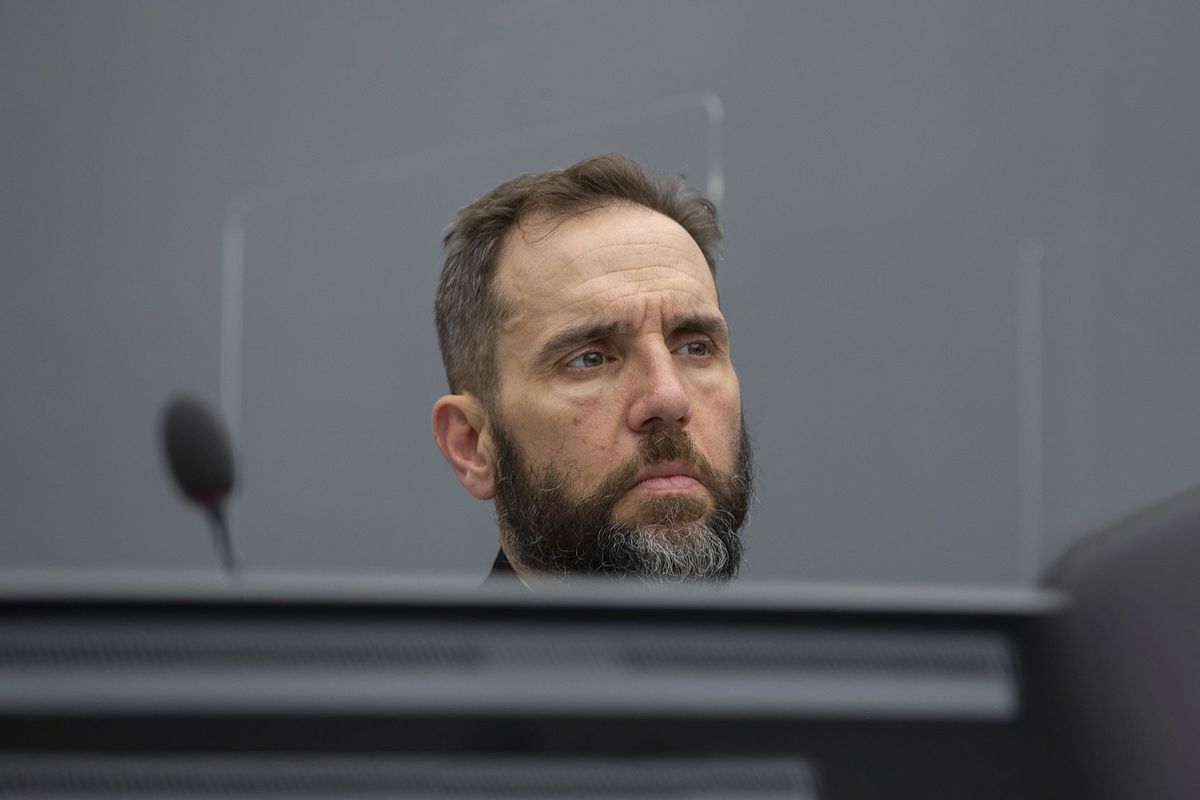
top-left (433, 154), bottom-right (721, 408)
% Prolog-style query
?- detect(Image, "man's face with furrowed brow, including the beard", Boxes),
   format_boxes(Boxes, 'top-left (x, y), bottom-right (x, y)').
top-left (488, 206), bottom-right (750, 578)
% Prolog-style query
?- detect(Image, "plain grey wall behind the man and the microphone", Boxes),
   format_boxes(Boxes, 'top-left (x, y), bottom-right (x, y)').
top-left (0, 0), bottom-right (1200, 584)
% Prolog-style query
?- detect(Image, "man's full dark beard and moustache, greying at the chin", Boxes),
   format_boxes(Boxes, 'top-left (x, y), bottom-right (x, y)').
top-left (493, 420), bottom-right (751, 582)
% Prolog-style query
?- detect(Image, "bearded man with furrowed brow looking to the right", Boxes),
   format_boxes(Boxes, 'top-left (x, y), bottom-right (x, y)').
top-left (433, 155), bottom-right (751, 585)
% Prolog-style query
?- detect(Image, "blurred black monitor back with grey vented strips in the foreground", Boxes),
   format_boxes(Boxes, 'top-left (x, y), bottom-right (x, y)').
top-left (0, 575), bottom-right (1062, 800)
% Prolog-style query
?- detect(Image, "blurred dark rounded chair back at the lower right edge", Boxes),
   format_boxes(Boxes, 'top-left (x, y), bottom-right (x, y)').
top-left (1045, 487), bottom-right (1200, 800)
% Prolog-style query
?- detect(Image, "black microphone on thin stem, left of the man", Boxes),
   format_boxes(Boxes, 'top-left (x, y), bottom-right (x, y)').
top-left (162, 395), bottom-right (238, 575)
